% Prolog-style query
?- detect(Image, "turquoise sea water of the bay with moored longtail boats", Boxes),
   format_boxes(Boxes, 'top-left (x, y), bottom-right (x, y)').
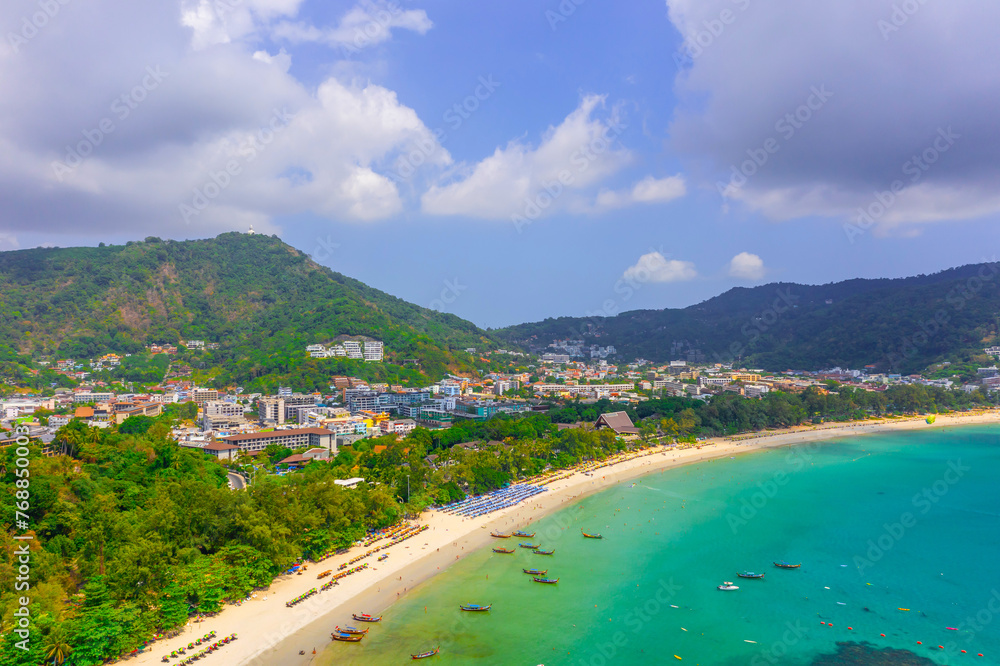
top-left (317, 427), bottom-right (1000, 666)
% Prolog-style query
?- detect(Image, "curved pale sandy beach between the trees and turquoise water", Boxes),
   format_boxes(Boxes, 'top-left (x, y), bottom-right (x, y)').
top-left (130, 410), bottom-right (1000, 666)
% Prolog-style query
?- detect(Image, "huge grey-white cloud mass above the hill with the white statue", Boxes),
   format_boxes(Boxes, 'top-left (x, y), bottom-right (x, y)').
top-left (0, 0), bottom-right (442, 236)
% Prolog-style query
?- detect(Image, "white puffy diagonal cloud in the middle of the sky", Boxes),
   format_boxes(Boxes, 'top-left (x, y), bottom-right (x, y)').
top-left (422, 95), bottom-right (631, 219)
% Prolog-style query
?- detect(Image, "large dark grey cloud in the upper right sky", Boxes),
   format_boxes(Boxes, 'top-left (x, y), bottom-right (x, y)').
top-left (667, 0), bottom-right (1000, 232)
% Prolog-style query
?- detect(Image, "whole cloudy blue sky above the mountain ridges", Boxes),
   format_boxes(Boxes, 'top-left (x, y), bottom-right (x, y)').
top-left (0, 0), bottom-right (1000, 327)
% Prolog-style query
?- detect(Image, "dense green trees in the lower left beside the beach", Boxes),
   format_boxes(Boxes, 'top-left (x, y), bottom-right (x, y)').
top-left (0, 421), bottom-right (400, 666)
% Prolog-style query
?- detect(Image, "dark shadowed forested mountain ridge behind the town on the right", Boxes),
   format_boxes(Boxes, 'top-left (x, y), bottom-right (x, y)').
top-left (494, 263), bottom-right (1000, 372)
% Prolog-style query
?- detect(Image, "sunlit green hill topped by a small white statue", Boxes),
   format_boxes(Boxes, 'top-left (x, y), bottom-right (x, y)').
top-left (0, 233), bottom-right (489, 388)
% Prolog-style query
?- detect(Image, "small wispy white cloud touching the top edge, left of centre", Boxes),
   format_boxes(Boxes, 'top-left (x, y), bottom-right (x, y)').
top-left (272, 0), bottom-right (434, 53)
